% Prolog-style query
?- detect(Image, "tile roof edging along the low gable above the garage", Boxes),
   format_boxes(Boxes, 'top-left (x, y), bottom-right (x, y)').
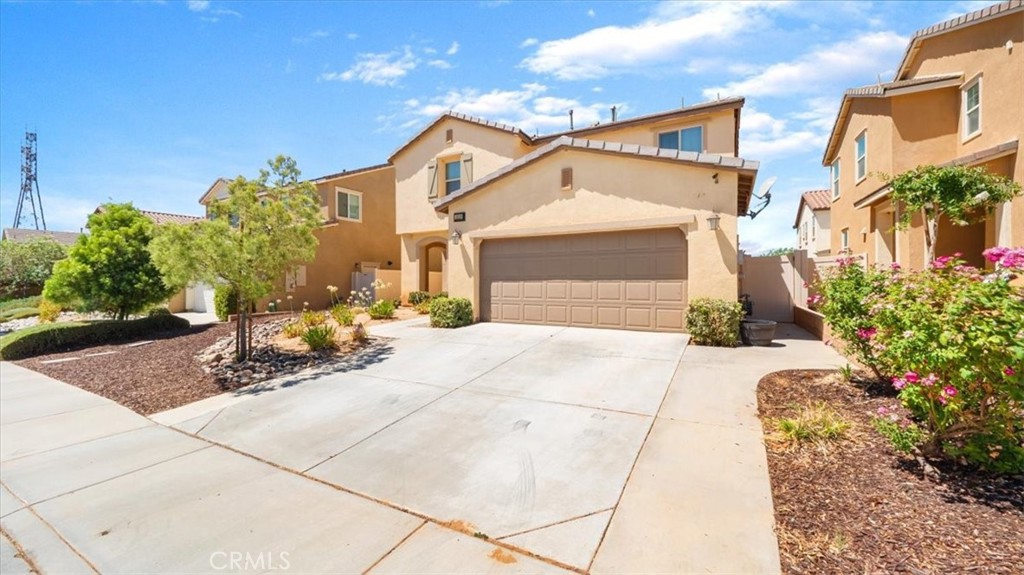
top-left (434, 136), bottom-right (759, 211)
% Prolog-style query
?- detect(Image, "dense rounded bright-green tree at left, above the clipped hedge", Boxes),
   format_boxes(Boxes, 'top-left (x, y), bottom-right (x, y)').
top-left (43, 204), bottom-right (180, 319)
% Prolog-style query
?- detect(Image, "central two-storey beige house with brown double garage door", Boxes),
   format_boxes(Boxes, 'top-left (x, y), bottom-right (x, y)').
top-left (389, 98), bottom-right (758, 331)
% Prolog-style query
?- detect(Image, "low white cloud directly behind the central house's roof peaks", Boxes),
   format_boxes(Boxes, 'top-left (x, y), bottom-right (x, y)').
top-left (393, 83), bottom-right (629, 133)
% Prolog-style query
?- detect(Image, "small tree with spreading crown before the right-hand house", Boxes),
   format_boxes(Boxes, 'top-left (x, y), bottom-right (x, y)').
top-left (889, 166), bottom-right (1021, 262)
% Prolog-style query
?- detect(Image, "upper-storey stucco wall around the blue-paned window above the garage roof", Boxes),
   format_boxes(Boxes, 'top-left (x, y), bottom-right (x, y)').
top-left (561, 109), bottom-right (736, 156)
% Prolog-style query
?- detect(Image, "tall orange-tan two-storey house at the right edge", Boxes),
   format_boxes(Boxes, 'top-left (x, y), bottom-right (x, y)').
top-left (822, 0), bottom-right (1024, 268)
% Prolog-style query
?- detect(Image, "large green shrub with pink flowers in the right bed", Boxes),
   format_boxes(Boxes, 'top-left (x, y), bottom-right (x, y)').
top-left (821, 249), bottom-right (1024, 473)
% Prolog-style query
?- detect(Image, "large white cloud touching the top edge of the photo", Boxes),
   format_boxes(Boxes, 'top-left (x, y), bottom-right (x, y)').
top-left (522, 2), bottom-right (777, 80)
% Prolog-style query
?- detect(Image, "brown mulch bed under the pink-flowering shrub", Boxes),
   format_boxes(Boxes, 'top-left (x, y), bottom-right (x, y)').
top-left (758, 370), bottom-right (1024, 575)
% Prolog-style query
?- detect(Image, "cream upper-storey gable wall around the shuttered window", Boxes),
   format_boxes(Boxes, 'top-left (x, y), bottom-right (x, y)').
top-left (393, 118), bottom-right (529, 234)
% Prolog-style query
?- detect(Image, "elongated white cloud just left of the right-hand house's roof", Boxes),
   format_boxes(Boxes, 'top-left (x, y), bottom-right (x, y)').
top-left (703, 32), bottom-right (906, 98)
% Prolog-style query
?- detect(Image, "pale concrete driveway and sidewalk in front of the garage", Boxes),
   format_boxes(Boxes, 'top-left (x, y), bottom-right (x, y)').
top-left (0, 320), bottom-right (837, 573)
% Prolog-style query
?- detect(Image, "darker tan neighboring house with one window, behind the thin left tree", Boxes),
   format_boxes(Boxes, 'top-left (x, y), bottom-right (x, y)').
top-left (200, 164), bottom-right (400, 311)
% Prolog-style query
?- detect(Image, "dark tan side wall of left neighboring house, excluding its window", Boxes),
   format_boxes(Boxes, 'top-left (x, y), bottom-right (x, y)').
top-left (258, 167), bottom-right (401, 311)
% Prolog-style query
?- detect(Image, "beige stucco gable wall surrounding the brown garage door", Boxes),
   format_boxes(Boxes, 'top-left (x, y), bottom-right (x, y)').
top-left (447, 150), bottom-right (738, 317)
